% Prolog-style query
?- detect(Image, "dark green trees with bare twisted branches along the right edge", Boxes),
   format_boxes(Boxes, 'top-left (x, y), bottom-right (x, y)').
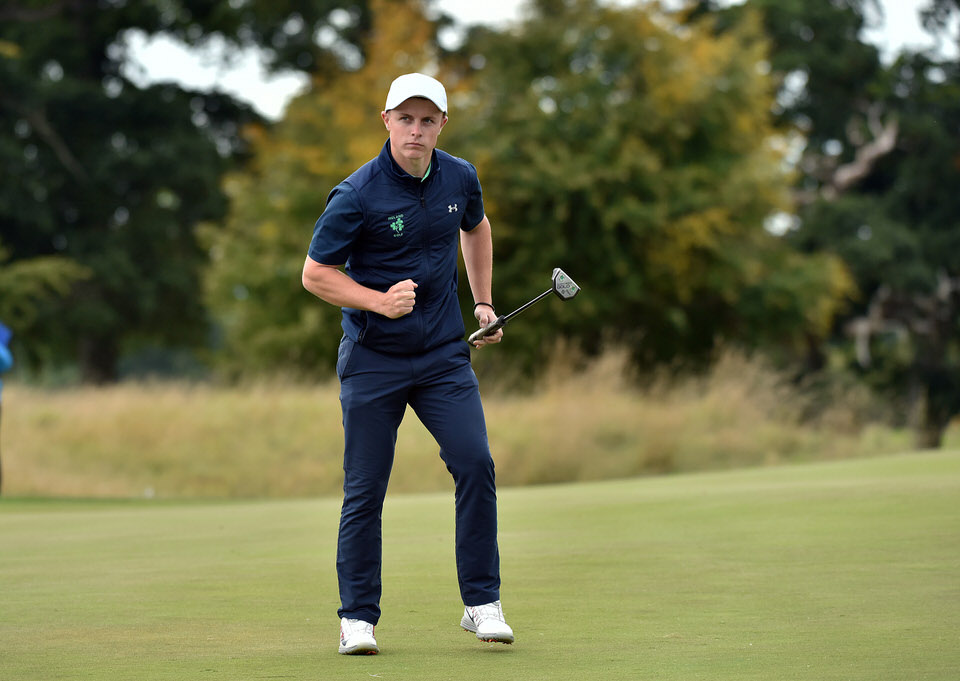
top-left (701, 0), bottom-right (960, 447)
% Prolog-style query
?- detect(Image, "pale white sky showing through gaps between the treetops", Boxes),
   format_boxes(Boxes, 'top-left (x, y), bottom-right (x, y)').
top-left (126, 0), bottom-right (956, 118)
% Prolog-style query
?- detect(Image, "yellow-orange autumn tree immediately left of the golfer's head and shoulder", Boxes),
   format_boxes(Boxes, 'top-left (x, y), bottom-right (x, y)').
top-left (205, 0), bottom-right (444, 375)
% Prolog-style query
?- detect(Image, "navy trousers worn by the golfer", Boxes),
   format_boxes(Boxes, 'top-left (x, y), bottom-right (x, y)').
top-left (337, 338), bottom-right (500, 624)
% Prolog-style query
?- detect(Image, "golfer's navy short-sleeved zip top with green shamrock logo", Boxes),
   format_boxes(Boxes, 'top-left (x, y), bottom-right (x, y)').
top-left (309, 139), bottom-right (484, 354)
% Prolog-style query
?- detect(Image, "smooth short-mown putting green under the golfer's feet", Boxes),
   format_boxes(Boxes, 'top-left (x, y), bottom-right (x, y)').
top-left (0, 452), bottom-right (960, 681)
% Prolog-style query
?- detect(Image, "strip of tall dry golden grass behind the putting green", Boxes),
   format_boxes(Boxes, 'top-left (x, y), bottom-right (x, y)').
top-left (2, 353), bottom-right (944, 498)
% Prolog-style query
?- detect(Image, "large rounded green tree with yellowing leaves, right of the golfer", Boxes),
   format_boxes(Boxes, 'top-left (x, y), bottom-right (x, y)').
top-left (448, 0), bottom-right (849, 366)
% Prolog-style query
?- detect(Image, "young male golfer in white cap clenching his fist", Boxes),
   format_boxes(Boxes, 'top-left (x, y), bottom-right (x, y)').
top-left (303, 73), bottom-right (513, 654)
